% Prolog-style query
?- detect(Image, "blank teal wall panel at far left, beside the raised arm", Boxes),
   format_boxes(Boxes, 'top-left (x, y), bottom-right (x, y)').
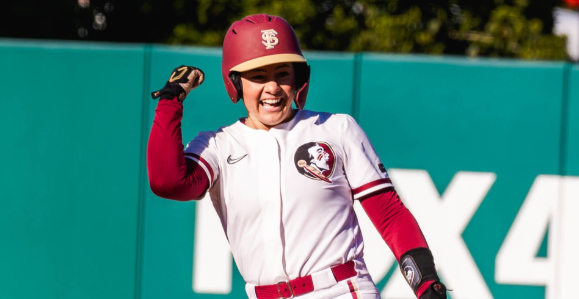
top-left (0, 41), bottom-right (145, 299)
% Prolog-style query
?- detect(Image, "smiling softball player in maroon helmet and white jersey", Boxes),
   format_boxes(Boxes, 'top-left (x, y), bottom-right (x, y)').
top-left (147, 14), bottom-right (446, 299)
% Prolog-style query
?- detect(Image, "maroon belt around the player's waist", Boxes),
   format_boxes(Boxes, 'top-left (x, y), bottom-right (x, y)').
top-left (255, 261), bottom-right (357, 299)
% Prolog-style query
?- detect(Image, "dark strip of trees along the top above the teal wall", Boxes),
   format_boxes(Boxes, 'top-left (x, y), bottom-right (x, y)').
top-left (0, 0), bottom-right (575, 60)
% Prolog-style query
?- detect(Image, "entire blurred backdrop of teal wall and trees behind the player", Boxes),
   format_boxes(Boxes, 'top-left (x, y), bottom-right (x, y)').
top-left (0, 0), bottom-right (579, 299)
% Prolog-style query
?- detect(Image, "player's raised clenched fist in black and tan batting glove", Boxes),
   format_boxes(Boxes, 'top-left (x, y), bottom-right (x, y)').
top-left (151, 65), bottom-right (205, 102)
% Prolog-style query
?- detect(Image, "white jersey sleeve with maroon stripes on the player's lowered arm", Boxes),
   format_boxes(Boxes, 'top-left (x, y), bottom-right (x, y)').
top-left (342, 115), bottom-right (392, 200)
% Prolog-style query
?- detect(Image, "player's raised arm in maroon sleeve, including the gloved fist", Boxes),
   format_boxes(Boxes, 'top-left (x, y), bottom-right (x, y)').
top-left (147, 65), bottom-right (209, 200)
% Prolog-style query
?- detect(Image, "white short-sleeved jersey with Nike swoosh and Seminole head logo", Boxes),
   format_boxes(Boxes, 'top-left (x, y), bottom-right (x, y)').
top-left (185, 110), bottom-right (392, 285)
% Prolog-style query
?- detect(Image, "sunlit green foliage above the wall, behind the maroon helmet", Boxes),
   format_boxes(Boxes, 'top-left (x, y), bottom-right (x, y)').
top-left (167, 0), bottom-right (567, 60)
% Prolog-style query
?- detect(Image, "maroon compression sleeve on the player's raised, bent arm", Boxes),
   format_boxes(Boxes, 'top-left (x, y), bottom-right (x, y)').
top-left (147, 98), bottom-right (209, 200)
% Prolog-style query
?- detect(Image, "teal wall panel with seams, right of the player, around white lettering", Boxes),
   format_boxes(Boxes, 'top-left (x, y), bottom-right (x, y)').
top-left (359, 54), bottom-right (564, 298)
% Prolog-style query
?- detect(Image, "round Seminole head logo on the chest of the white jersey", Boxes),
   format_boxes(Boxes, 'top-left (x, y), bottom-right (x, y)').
top-left (294, 141), bottom-right (336, 184)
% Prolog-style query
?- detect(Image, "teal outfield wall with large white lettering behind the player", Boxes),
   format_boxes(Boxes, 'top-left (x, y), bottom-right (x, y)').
top-left (0, 40), bottom-right (579, 299)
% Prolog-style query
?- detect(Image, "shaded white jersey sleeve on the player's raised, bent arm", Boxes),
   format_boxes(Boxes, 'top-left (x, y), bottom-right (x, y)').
top-left (184, 132), bottom-right (219, 189)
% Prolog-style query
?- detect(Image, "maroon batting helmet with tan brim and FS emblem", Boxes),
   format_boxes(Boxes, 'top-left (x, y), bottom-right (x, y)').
top-left (221, 14), bottom-right (310, 109)
